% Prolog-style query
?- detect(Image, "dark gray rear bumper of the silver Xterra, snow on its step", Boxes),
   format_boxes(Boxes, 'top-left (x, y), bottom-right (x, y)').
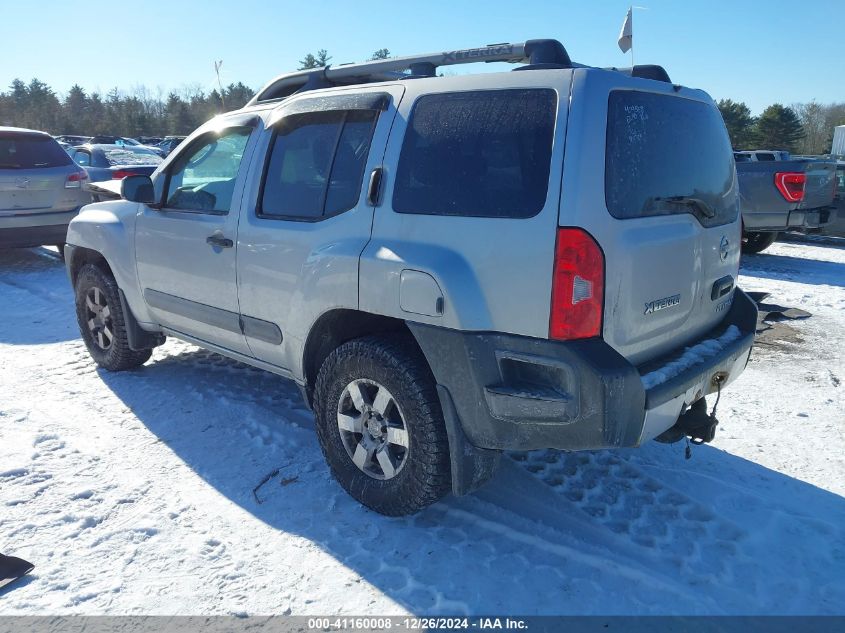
top-left (408, 289), bottom-right (757, 450)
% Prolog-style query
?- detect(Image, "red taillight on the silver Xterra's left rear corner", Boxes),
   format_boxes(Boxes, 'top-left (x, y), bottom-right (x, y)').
top-left (549, 228), bottom-right (604, 340)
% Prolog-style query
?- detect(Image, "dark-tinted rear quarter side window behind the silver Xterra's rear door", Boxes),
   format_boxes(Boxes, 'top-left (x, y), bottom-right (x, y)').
top-left (393, 89), bottom-right (557, 218)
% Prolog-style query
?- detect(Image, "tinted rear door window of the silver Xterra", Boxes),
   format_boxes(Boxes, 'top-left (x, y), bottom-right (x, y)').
top-left (258, 110), bottom-right (378, 220)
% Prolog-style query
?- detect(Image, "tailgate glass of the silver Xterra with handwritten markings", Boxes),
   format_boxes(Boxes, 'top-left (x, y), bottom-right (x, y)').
top-left (605, 90), bottom-right (739, 226)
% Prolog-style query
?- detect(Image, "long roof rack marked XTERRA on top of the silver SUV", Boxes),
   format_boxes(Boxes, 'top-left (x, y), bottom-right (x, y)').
top-left (247, 39), bottom-right (574, 105)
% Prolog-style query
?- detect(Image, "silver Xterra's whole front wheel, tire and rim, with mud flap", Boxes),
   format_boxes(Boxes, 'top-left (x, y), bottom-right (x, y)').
top-left (75, 264), bottom-right (152, 371)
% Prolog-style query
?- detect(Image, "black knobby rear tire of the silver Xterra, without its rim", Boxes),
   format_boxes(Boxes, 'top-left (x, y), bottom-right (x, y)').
top-left (314, 335), bottom-right (451, 516)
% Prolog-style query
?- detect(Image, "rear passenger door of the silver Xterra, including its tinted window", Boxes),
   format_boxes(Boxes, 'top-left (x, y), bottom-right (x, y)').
top-left (237, 85), bottom-right (404, 369)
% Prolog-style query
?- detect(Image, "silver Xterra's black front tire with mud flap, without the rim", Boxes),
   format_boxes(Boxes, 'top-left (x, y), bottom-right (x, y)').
top-left (74, 264), bottom-right (152, 371)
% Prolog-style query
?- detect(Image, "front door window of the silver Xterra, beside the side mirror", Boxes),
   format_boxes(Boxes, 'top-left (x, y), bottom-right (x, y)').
top-left (164, 127), bottom-right (252, 213)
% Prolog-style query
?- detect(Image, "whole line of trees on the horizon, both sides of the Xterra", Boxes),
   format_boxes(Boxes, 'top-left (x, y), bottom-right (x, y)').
top-left (0, 48), bottom-right (845, 154)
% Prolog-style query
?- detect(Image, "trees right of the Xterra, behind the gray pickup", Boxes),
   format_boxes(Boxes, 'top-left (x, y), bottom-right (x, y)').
top-left (718, 99), bottom-right (845, 154)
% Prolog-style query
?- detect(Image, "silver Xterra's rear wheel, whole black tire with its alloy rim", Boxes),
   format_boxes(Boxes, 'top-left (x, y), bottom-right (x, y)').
top-left (314, 337), bottom-right (451, 516)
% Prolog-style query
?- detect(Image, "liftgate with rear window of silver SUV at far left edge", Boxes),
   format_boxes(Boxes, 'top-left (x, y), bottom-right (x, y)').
top-left (0, 132), bottom-right (79, 215)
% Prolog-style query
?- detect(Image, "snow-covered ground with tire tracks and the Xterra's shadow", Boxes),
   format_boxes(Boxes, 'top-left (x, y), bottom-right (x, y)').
top-left (0, 243), bottom-right (845, 615)
